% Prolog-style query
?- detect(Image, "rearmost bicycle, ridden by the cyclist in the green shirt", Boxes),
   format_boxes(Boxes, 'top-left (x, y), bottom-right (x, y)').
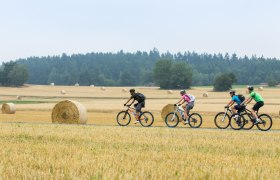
top-left (231, 106), bottom-right (272, 131)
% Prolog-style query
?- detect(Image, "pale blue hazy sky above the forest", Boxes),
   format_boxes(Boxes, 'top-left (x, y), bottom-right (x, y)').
top-left (0, 0), bottom-right (280, 62)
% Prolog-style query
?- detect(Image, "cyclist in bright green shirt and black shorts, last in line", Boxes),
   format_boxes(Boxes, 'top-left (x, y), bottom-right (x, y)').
top-left (241, 86), bottom-right (264, 124)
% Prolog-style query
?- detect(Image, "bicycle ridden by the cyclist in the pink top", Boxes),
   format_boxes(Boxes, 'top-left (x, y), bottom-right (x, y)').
top-left (165, 104), bottom-right (202, 128)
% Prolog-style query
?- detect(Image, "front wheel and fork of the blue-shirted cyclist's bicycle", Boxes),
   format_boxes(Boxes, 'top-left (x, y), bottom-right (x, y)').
top-left (214, 107), bottom-right (233, 129)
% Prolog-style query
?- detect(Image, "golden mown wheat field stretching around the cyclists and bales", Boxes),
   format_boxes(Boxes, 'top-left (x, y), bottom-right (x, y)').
top-left (0, 86), bottom-right (280, 179)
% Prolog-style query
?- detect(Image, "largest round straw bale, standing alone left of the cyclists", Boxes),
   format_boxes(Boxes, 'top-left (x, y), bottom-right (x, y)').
top-left (52, 100), bottom-right (87, 124)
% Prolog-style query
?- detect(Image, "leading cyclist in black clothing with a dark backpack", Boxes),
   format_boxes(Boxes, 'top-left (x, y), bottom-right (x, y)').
top-left (124, 89), bottom-right (146, 124)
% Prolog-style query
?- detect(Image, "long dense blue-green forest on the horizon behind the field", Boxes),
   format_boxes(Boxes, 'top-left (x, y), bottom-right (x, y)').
top-left (2, 49), bottom-right (280, 88)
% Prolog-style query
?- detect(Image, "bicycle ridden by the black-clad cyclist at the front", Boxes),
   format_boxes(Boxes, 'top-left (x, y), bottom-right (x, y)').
top-left (117, 106), bottom-right (154, 127)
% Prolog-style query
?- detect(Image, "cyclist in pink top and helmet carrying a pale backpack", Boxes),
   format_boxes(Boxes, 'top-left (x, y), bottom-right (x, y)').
top-left (174, 90), bottom-right (195, 124)
